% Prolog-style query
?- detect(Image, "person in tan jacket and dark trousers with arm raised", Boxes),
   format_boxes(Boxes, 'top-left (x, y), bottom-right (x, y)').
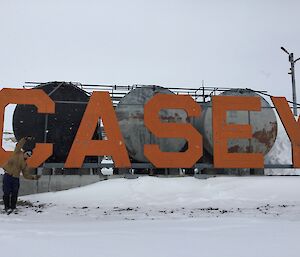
top-left (3, 137), bottom-right (40, 212)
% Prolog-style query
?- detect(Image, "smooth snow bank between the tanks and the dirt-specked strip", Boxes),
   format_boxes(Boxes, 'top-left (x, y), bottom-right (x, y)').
top-left (22, 177), bottom-right (300, 209)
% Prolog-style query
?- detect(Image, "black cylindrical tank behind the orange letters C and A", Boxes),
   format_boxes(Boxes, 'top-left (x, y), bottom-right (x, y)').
top-left (13, 82), bottom-right (98, 163)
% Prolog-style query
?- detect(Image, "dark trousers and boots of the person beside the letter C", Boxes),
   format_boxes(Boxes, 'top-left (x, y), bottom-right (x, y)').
top-left (3, 173), bottom-right (20, 209)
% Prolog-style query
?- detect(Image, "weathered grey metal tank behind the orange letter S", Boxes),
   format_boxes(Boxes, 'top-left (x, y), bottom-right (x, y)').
top-left (116, 86), bottom-right (187, 162)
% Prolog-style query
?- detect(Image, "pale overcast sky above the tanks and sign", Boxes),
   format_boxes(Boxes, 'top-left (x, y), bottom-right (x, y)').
top-left (0, 0), bottom-right (300, 130)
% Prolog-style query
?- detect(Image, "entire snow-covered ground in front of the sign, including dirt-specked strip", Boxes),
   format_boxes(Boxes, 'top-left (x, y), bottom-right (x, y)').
top-left (0, 177), bottom-right (300, 257)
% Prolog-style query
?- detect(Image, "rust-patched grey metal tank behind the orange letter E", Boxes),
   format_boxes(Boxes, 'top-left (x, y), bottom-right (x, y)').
top-left (192, 89), bottom-right (277, 155)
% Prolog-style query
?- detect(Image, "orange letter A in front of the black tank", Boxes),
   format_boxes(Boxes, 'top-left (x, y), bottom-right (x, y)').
top-left (65, 92), bottom-right (130, 168)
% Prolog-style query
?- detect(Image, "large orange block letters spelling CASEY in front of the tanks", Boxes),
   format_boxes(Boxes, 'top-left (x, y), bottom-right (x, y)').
top-left (0, 88), bottom-right (300, 168)
